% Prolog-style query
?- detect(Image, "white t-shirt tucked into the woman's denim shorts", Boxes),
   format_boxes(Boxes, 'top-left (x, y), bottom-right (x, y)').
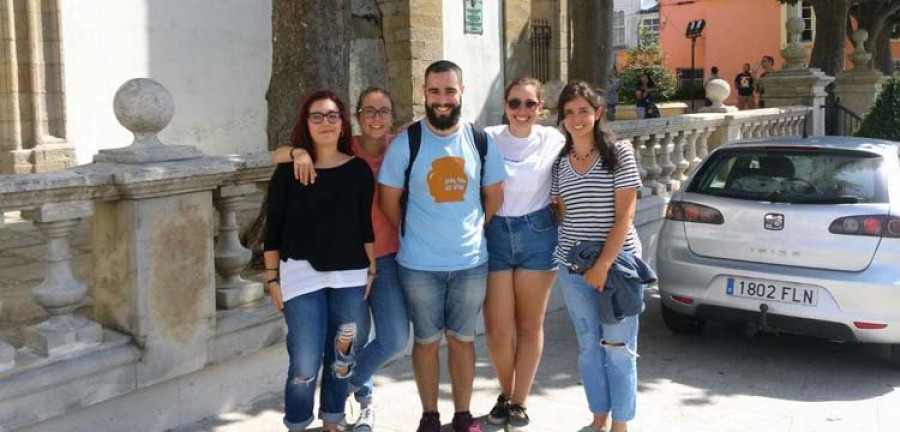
top-left (485, 125), bottom-right (566, 217)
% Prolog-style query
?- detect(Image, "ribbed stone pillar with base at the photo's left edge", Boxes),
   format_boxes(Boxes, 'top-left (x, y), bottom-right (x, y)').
top-left (0, 0), bottom-right (76, 174)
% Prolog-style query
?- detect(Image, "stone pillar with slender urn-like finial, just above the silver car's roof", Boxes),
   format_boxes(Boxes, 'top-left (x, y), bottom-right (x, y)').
top-left (759, 5), bottom-right (834, 136)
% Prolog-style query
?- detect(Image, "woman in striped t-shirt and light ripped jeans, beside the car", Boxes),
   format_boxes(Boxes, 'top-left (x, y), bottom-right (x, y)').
top-left (551, 82), bottom-right (643, 432)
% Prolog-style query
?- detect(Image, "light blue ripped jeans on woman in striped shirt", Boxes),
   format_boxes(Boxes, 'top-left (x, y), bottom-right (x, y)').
top-left (559, 270), bottom-right (640, 421)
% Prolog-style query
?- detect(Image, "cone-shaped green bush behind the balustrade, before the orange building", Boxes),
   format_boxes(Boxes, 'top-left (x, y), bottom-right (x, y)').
top-left (619, 28), bottom-right (675, 104)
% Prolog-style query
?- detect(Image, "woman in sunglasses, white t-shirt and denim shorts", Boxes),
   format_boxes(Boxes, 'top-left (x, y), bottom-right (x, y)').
top-left (484, 77), bottom-right (565, 428)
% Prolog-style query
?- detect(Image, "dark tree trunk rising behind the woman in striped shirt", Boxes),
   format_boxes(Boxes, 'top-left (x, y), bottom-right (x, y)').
top-left (569, 0), bottom-right (613, 88)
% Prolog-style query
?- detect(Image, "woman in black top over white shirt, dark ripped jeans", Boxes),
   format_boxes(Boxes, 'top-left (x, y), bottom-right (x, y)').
top-left (263, 90), bottom-right (375, 431)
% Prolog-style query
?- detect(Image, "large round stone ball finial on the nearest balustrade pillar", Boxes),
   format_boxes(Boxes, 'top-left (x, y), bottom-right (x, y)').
top-left (113, 78), bottom-right (175, 147)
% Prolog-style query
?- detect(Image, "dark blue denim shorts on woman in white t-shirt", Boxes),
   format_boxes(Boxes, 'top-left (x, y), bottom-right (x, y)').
top-left (485, 208), bottom-right (557, 272)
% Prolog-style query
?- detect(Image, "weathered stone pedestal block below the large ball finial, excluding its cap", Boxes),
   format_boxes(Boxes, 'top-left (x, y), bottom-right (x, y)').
top-left (92, 191), bottom-right (215, 386)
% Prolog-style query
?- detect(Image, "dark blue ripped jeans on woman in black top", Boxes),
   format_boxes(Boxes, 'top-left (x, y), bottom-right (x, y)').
top-left (284, 286), bottom-right (365, 431)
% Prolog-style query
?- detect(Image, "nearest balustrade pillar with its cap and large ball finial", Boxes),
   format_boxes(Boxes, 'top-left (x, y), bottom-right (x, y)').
top-left (91, 79), bottom-right (236, 387)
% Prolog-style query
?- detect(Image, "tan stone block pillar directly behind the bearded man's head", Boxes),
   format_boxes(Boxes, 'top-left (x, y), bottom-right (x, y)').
top-left (378, 0), bottom-right (444, 124)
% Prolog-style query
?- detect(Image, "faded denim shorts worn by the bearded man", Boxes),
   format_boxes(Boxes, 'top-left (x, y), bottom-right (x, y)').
top-left (400, 263), bottom-right (487, 344)
